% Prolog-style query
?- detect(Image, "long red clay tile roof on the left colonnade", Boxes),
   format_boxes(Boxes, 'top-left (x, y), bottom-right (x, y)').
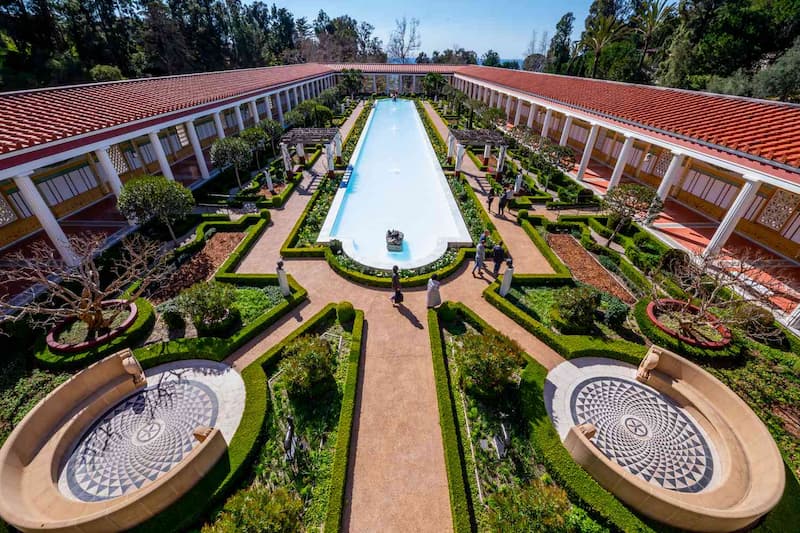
top-left (0, 64), bottom-right (332, 158)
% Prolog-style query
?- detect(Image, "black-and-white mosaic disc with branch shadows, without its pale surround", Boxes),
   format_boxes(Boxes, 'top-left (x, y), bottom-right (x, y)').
top-left (60, 379), bottom-right (219, 502)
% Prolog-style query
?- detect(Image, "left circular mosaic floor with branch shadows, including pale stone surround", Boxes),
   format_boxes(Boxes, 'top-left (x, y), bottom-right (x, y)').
top-left (59, 362), bottom-right (244, 502)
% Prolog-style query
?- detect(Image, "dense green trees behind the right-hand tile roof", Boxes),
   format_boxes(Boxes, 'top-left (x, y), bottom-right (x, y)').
top-left (532, 0), bottom-right (800, 101)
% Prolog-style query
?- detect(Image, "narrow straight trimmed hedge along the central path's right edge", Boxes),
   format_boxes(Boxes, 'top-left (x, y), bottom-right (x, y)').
top-left (428, 302), bottom-right (476, 533)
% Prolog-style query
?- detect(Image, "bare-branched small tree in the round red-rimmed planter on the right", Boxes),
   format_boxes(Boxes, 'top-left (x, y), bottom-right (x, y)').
top-left (652, 251), bottom-right (791, 341)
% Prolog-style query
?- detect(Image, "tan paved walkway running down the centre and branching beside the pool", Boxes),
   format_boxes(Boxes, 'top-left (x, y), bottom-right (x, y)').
top-left (223, 101), bottom-right (562, 532)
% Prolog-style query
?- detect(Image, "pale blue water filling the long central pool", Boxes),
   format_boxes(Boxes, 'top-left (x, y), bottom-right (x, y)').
top-left (318, 99), bottom-right (472, 269)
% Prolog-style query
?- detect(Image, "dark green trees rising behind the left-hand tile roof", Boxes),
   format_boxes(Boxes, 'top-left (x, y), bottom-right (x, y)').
top-left (0, 0), bottom-right (386, 90)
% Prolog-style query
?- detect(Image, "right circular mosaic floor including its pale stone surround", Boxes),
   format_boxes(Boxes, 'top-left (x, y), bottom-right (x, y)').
top-left (545, 357), bottom-right (720, 493)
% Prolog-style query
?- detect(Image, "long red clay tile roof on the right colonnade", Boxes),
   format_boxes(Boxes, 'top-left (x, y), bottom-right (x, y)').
top-left (458, 66), bottom-right (800, 176)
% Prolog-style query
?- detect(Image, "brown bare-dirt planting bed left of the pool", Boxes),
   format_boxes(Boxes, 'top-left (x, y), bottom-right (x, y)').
top-left (150, 231), bottom-right (245, 304)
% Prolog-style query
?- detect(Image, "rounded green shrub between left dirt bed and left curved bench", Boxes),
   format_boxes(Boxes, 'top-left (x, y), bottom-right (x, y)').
top-left (182, 281), bottom-right (238, 337)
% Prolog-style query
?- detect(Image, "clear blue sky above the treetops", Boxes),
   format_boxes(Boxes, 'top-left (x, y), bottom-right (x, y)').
top-left (276, 0), bottom-right (591, 59)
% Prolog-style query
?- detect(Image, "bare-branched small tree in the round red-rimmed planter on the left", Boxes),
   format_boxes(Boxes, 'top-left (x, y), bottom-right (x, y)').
top-left (0, 233), bottom-right (169, 338)
